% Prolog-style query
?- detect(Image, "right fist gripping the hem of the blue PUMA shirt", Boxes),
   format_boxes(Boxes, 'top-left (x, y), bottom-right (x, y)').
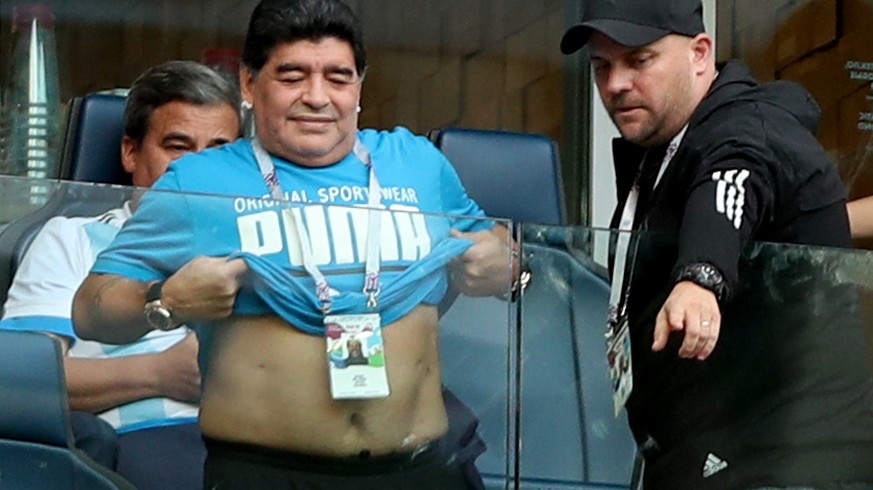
top-left (451, 226), bottom-right (512, 296)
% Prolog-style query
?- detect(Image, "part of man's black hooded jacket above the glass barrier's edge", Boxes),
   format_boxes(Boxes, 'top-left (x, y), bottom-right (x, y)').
top-left (613, 62), bottom-right (851, 287)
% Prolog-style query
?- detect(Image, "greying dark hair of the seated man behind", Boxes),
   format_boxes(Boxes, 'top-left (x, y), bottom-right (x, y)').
top-left (124, 61), bottom-right (240, 144)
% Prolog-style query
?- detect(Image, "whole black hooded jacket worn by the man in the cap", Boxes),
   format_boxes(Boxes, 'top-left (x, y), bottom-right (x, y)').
top-left (613, 62), bottom-right (873, 490)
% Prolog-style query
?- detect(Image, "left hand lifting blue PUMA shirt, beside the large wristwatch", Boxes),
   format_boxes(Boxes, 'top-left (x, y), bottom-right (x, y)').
top-left (161, 257), bottom-right (249, 324)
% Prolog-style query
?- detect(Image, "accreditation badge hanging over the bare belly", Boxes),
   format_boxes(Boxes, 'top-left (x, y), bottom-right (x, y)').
top-left (324, 313), bottom-right (390, 400)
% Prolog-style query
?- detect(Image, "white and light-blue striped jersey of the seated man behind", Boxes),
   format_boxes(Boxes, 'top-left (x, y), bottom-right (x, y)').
top-left (0, 205), bottom-right (198, 433)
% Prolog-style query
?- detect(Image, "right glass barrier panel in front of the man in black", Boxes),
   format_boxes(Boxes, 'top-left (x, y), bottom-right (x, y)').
top-left (518, 224), bottom-right (873, 488)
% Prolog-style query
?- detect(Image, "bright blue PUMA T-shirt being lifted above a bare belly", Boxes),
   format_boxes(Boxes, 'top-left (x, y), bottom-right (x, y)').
top-left (93, 128), bottom-right (491, 334)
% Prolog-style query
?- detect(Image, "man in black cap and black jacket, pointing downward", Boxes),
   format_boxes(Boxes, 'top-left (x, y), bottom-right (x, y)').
top-left (561, 0), bottom-right (873, 489)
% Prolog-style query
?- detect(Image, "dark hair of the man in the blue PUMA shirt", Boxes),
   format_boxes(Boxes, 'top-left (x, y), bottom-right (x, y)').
top-left (242, 0), bottom-right (367, 76)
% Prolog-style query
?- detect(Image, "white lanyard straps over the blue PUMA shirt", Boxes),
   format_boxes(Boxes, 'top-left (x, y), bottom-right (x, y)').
top-left (252, 138), bottom-right (382, 315)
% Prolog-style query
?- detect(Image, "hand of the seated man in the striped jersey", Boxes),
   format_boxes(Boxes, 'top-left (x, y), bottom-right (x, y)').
top-left (155, 332), bottom-right (200, 403)
